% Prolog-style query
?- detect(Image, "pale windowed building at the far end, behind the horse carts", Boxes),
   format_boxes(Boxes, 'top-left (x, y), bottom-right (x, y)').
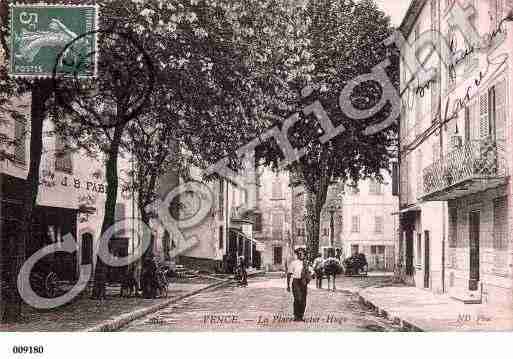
top-left (292, 171), bottom-right (399, 271)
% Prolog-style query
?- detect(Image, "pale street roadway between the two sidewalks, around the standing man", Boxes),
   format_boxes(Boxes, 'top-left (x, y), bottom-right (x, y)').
top-left (123, 277), bottom-right (399, 331)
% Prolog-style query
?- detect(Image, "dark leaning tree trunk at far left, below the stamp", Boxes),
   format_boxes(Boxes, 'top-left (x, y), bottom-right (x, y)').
top-left (2, 80), bottom-right (51, 322)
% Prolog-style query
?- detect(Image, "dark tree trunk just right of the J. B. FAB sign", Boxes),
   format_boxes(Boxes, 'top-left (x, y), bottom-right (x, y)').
top-left (92, 124), bottom-right (125, 299)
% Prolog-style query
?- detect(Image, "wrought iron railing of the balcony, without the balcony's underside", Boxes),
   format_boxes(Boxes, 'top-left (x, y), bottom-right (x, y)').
top-left (422, 140), bottom-right (507, 196)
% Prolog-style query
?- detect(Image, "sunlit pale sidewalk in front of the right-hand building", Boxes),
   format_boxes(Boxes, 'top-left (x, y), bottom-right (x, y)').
top-left (358, 287), bottom-right (513, 332)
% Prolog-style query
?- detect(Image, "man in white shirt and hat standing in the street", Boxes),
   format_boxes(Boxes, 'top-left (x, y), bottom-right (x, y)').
top-left (287, 248), bottom-right (312, 322)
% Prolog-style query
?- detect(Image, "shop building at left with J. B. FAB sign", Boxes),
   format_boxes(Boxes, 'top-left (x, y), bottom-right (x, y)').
top-left (0, 96), bottom-right (138, 298)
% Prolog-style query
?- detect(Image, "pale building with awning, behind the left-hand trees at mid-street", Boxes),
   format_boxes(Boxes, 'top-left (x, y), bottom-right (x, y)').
top-left (154, 160), bottom-right (262, 273)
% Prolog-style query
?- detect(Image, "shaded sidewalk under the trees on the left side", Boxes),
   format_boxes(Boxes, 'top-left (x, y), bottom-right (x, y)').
top-left (0, 277), bottom-right (224, 332)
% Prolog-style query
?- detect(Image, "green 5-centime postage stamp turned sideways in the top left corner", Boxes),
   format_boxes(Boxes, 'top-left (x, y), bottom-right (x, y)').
top-left (9, 4), bottom-right (98, 78)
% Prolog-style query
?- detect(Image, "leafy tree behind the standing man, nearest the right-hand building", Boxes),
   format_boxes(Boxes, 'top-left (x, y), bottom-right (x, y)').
top-left (258, 0), bottom-right (399, 258)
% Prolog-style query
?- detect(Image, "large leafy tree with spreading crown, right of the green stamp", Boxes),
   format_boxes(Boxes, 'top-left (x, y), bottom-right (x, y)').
top-left (55, 0), bottom-right (304, 297)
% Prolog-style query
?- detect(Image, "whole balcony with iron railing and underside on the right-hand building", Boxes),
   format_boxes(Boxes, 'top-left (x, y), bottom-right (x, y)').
top-left (420, 140), bottom-right (508, 201)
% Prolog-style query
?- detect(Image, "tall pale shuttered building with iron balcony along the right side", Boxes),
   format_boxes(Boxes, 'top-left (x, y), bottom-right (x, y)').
top-left (399, 0), bottom-right (513, 303)
